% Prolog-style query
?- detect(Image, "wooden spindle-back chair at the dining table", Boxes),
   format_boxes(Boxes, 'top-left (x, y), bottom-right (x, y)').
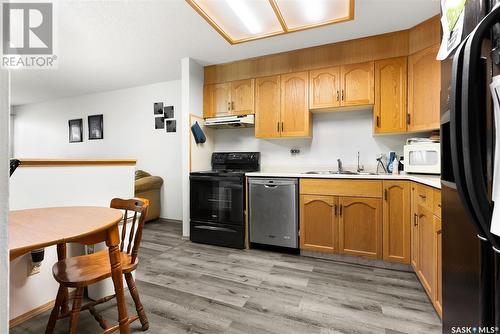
top-left (45, 198), bottom-right (149, 334)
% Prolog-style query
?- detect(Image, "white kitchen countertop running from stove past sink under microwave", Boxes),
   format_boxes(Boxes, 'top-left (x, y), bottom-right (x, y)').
top-left (245, 171), bottom-right (441, 189)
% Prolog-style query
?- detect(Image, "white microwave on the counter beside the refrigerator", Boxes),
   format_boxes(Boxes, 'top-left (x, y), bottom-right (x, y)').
top-left (404, 143), bottom-right (441, 174)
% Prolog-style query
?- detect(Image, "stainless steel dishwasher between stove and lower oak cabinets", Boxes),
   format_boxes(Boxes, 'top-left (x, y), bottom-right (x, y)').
top-left (248, 178), bottom-right (299, 249)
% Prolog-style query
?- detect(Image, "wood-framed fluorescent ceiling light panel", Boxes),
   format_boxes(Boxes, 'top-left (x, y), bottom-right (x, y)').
top-left (186, 0), bottom-right (354, 44)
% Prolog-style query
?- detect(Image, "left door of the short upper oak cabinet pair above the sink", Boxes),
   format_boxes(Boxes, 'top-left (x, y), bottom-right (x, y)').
top-left (309, 67), bottom-right (340, 109)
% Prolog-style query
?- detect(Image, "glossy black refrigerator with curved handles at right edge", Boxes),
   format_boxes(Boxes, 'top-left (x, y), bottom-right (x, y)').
top-left (441, 0), bottom-right (500, 333)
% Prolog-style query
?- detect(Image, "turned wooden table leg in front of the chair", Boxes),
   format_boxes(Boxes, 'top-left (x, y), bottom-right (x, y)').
top-left (106, 225), bottom-right (130, 334)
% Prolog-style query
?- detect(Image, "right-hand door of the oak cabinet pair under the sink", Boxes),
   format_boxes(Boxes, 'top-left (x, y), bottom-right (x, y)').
top-left (339, 197), bottom-right (382, 259)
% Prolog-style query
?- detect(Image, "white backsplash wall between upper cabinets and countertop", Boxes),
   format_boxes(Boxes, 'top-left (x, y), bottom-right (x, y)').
top-left (215, 110), bottom-right (422, 170)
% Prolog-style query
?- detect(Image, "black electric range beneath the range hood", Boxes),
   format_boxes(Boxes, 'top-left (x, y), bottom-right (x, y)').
top-left (189, 152), bottom-right (260, 248)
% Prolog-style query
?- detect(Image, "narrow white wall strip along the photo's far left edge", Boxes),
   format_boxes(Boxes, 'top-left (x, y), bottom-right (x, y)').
top-left (0, 69), bottom-right (10, 333)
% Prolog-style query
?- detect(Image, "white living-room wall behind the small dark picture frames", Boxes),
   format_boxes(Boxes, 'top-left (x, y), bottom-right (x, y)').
top-left (14, 80), bottom-right (182, 220)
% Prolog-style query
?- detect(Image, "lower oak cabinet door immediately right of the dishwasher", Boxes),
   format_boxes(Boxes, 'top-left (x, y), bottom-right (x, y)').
top-left (300, 195), bottom-right (338, 253)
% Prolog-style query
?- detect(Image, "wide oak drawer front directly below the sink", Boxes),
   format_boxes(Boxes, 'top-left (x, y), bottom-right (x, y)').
top-left (300, 179), bottom-right (382, 198)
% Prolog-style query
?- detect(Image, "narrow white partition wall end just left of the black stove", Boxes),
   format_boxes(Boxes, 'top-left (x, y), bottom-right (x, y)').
top-left (181, 58), bottom-right (204, 237)
